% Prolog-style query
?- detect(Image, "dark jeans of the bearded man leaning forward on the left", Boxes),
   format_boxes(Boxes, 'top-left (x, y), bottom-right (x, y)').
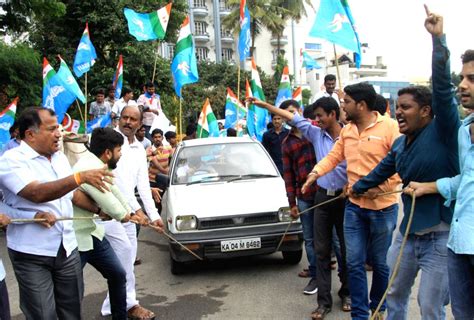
top-left (80, 236), bottom-right (127, 320)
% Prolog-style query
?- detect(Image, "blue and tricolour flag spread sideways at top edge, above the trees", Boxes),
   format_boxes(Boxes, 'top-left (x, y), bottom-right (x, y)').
top-left (124, 3), bottom-right (172, 41)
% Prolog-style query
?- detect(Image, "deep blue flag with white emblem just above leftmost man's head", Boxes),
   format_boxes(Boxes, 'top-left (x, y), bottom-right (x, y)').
top-left (42, 58), bottom-right (76, 123)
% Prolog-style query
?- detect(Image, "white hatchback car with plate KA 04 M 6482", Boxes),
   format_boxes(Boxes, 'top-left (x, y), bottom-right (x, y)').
top-left (162, 137), bottom-right (303, 274)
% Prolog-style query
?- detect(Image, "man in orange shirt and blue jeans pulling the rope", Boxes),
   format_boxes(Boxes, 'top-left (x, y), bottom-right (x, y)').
top-left (302, 83), bottom-right (400, 319)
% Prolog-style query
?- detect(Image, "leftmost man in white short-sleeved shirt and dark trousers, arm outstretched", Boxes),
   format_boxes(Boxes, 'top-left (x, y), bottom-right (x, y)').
top-left (0, 107), bottom-right (112, 320)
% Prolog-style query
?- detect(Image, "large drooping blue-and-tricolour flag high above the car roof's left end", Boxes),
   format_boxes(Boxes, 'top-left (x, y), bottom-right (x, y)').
top-left (171, 16), bottom-right (199, 98)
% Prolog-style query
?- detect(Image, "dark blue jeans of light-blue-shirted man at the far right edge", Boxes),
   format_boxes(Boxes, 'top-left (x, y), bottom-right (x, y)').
top-left (448, 249), bottom-right (474, 320)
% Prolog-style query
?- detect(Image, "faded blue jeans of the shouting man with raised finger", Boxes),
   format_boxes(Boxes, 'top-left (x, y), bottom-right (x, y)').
top-left (387, 231), bottom-right (448, 320)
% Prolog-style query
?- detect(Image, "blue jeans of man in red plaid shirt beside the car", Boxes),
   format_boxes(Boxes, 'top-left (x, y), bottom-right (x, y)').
top-left (298, 199), bottom-right (316, 279)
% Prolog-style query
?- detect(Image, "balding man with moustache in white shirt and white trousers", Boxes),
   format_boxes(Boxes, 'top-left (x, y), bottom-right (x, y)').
top-left (102, 106), bottom-right (163, 319)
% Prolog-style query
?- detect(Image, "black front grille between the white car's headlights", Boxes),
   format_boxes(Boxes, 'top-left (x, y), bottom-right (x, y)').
top-left (198, 212), bottom-right (278, 230)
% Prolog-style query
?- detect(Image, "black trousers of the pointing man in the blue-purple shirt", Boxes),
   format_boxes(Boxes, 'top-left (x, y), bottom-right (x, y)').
top-left (314, 190), bottom-right (349, 308)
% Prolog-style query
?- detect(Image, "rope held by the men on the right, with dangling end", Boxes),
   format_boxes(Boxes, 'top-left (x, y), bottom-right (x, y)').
top-left (275, 189), bottom-right (416, 320)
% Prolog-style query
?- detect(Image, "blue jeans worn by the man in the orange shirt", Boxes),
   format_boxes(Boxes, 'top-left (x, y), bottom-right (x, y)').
top-left (344, 201), bottom-right (398, 320)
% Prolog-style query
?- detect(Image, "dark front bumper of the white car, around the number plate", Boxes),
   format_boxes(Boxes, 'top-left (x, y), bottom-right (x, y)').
top-left (169, 222), bottom-right (303, 262)
